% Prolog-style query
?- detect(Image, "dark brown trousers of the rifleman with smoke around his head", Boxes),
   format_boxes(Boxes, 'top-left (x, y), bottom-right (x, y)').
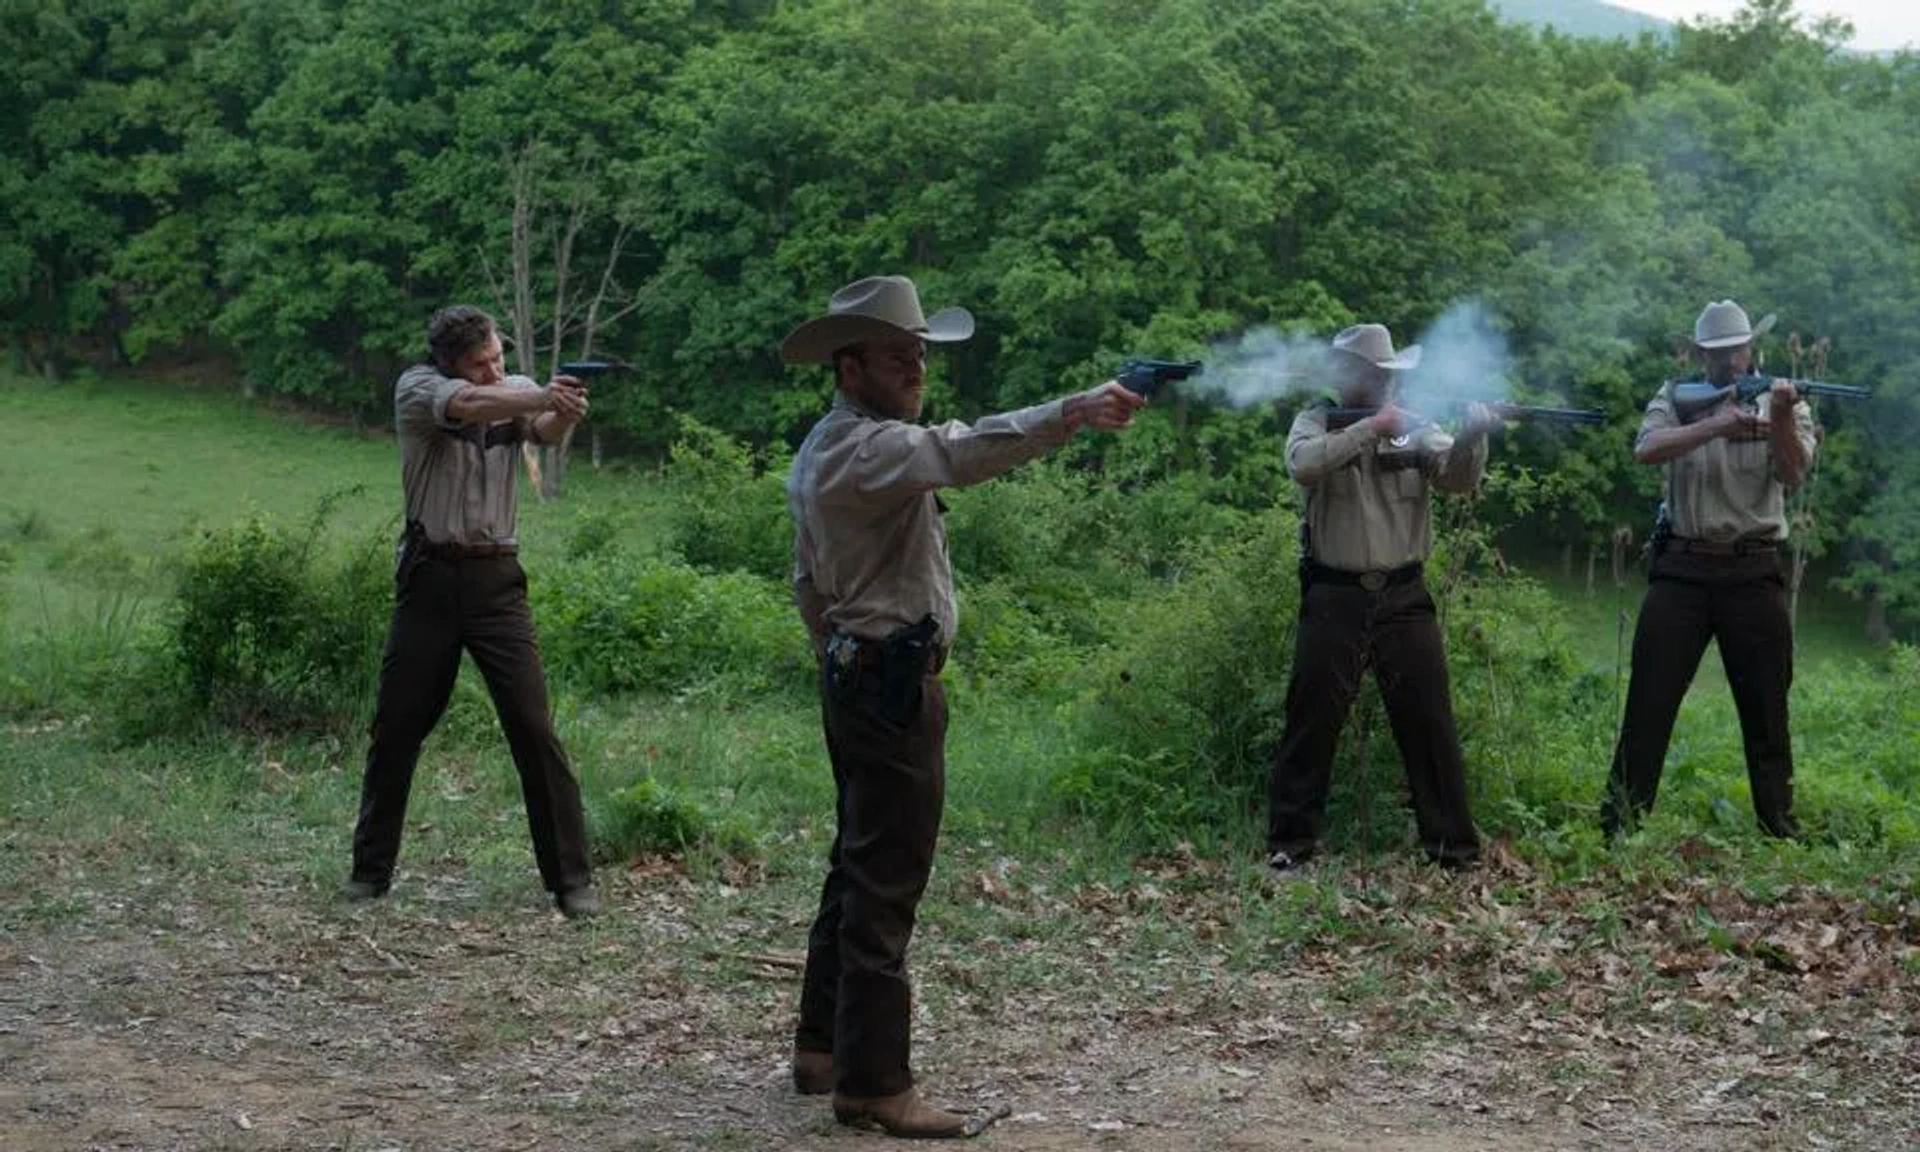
top-left (1267, 576), bottom-right (1480, 862)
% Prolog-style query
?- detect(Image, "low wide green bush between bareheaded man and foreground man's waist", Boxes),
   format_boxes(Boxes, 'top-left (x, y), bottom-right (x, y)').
top-left (532, 549), bottom-right (812, 699)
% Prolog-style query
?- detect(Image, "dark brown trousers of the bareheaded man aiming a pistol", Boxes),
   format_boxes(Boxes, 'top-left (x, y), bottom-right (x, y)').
top-left (353, 555), bottom-right (593, 893)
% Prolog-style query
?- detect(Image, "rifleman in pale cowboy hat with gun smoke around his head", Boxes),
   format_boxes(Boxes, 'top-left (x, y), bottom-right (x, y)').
top-left (1267, 324), bottom-right (1500, 877)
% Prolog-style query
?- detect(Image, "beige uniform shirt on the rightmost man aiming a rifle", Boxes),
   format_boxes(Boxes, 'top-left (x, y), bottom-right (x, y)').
top-left (1640, 382), bottom-right (1816, 541)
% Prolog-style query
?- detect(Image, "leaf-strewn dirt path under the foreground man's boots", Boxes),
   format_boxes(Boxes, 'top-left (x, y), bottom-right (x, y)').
top-left (0, 874), bottom-right (1896, 1152)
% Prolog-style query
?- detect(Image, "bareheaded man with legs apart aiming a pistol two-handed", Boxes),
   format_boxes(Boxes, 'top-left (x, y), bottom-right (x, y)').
top-left (346, 305), bottom-right (599, 918)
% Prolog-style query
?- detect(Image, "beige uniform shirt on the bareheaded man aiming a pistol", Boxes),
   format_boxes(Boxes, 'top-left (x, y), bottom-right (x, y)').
top-left (394, 365), bottom-right (540, 543)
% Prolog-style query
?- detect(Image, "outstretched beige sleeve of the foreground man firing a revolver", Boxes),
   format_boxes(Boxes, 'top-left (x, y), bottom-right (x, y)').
top-left (841, 399), bottom-right (1068, 495)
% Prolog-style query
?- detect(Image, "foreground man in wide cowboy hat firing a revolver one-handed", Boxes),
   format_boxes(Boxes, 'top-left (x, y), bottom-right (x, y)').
top-left (780, 276), bottom-right (1144, 1137)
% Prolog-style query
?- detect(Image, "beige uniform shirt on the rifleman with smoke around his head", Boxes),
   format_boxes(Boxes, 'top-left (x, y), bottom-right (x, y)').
top-left (1286, 405), bottom-right (1486, 572)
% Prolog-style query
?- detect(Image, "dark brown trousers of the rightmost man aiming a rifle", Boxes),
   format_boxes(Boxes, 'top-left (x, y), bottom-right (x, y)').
top-left (1599, 551), bottom-right (1799, 837)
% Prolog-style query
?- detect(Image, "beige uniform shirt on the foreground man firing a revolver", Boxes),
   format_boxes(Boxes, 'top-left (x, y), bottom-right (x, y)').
top-left (787, 396), bottom-right (1068, 647)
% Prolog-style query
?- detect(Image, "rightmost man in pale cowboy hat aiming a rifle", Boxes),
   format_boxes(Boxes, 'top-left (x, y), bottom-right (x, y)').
top-left (1601, 300), bottom-right (1816, 837)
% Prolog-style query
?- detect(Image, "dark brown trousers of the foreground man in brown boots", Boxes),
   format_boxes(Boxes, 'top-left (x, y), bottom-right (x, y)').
top-left (793, 656), bottom-right (947, 1096)
